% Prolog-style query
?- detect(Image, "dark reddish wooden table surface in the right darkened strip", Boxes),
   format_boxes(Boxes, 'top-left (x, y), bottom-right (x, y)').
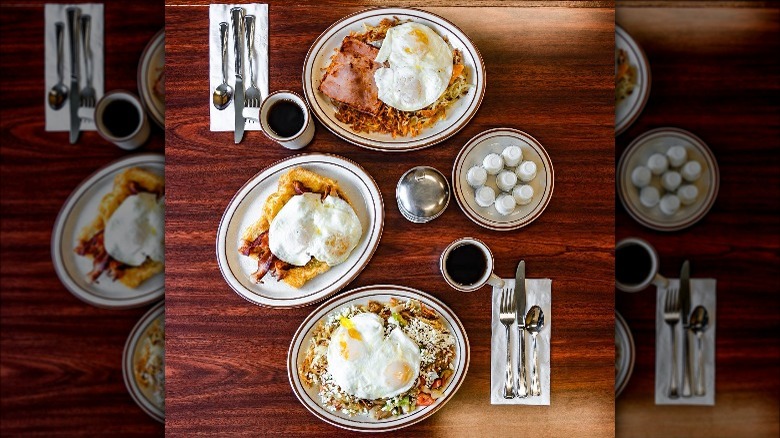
top-left (615, 5), bottom-right (780, 437)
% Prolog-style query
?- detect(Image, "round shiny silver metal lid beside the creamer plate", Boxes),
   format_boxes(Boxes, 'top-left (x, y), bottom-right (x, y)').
top-left (395, 166), bottom-right (450, 224)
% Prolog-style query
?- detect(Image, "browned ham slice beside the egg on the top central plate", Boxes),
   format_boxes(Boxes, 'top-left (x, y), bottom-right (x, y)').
top-left (319, 36), bottom-right (382, 114)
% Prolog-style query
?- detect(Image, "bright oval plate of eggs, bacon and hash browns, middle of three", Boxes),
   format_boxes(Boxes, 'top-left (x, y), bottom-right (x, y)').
top-left (216, 153), bottom-right (384, 308)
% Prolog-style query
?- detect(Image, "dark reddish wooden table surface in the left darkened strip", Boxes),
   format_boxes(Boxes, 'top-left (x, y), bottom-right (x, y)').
top-left (0, 1), bottom-right (164, 436)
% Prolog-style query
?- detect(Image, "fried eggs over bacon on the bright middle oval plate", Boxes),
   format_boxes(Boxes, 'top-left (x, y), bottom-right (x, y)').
top-left (268, 193), bottom-right (363, 266)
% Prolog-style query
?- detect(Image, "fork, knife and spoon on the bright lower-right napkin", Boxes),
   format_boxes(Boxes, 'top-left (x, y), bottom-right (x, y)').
top-left (499, 261), bottom-right (544, 399)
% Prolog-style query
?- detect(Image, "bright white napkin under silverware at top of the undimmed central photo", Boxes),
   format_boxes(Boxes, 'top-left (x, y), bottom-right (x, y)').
top-left (208, 3), bottom-right (268, 131)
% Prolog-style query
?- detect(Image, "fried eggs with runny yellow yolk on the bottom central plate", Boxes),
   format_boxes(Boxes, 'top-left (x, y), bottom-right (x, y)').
top-left (327, 313), bottom-right (420, 400)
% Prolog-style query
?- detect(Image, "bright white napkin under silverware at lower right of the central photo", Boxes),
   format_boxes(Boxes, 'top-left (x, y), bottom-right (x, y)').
top-left (490, 278), bottom-right (552, 406)
